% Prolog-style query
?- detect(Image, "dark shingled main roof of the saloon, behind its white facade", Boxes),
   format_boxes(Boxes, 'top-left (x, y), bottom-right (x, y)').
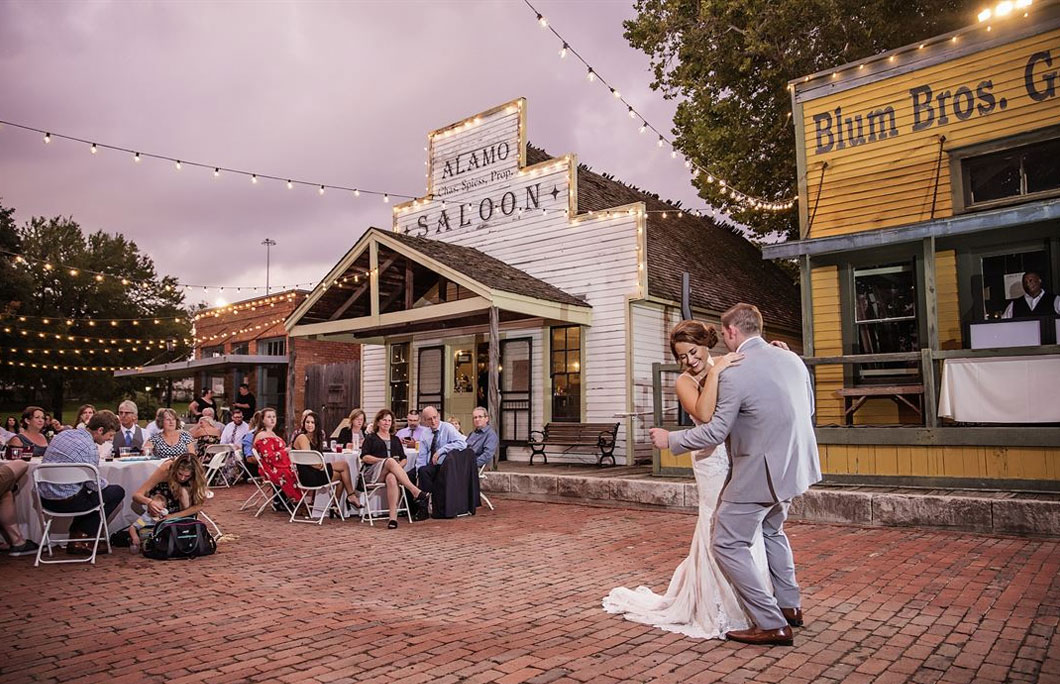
top-left (527, 145), bottom-right (801, 331)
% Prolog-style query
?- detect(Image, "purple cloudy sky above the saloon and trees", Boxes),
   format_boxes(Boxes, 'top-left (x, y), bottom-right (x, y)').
top-left (0, 0), bottom-right (720, 303)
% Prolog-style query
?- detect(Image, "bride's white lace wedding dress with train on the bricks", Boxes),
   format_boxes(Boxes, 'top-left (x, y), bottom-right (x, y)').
top-left (603, 434), bottom-right (770, 638)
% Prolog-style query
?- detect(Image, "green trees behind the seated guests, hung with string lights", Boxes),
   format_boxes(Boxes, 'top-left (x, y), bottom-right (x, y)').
top-left (0, 202), bottom-right (191, 418)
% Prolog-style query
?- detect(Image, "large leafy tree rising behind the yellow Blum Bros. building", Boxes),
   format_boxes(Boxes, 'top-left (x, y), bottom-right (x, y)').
top-left (624, 0), bottom-right (978, 238)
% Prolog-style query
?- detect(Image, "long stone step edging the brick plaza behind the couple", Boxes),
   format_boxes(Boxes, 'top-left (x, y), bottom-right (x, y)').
top-left (481, 469), bottom-right (1060, 537)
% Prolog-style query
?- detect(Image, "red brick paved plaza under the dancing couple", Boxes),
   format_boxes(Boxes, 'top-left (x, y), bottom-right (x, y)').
top-left (0, 487), bottom-right (1060, 684)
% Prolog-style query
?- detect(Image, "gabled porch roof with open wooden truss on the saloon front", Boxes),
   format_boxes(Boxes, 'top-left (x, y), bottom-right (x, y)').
top-left (285, 228), bottom-right (591, 341)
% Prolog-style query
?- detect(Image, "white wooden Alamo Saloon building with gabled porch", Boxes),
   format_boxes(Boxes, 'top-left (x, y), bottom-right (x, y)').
top-left (286, 99), bottom-right (801, 463)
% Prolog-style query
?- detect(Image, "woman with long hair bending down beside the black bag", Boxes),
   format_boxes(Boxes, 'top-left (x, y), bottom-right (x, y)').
top-left (129, 454), bottom-right (206, 554)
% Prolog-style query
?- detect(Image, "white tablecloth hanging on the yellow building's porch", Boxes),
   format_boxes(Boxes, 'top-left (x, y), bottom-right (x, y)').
top-left (938, 355), bottom-right (1060, 423)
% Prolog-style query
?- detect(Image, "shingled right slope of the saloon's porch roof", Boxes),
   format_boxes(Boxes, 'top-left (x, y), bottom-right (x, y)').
top-left (383, 228), bottom-right (589, 309)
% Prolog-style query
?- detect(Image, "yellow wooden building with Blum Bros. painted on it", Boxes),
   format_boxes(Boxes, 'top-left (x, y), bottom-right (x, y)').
top-left (764, 2), bottom-right (1060, 489)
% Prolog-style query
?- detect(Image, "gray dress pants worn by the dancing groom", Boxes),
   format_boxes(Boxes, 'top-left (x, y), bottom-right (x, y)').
top-left (713, 501), bottom-right (799, 630)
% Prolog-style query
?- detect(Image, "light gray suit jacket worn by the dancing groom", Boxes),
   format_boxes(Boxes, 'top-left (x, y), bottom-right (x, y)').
top-left (670, 337), bottom-right (820, 504)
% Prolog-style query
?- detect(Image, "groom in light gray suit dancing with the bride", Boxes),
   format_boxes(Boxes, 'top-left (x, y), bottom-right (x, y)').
top-left (651, 303), bottom-right (820, 646)
